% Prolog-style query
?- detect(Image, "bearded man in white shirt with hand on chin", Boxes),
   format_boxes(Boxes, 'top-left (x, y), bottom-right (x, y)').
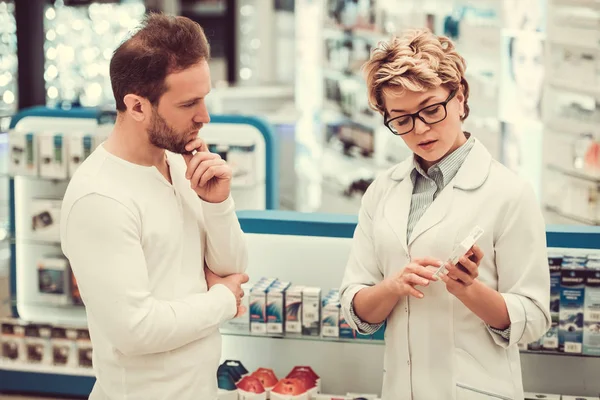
top-left (61, 14), bottom-right (248, 400)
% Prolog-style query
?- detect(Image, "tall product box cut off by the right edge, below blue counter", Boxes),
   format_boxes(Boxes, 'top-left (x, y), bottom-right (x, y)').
top-left (583, 256), bottom-right (600, 356)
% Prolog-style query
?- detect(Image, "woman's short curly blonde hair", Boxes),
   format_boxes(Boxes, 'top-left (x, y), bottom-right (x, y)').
top-left (363, 29), bottom-right (469, 121)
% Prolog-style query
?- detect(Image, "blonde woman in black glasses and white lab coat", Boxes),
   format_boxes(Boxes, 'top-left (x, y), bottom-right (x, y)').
top-left (341, 31), bottom-right (550, 400)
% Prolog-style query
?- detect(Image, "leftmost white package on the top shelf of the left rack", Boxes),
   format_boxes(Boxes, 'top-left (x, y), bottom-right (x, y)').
top-left (8, 131), bottom-right (38, 176)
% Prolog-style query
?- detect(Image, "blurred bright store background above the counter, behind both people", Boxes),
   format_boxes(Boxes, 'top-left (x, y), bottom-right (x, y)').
top-left (0, 0), bottom-right (600, 397)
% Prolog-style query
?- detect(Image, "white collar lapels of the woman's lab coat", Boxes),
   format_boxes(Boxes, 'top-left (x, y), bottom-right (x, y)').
top-left (390, 138), bottom-right (492, 190)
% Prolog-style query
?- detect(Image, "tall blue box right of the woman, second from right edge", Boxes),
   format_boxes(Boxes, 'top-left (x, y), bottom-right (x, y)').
top-left (558, 256), bottom-right (587, 353)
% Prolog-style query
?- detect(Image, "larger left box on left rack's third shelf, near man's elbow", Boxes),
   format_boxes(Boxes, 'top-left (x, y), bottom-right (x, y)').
top-left (37, 256), bottom-right (71, 305)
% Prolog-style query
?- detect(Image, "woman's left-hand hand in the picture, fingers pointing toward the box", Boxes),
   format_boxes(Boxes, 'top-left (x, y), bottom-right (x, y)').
top-left (384, 257), bottom-right (442, 299)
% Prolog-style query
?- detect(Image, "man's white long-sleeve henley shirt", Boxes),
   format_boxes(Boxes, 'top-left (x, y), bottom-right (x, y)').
top-left (61, 146), bottom-right (247, 400)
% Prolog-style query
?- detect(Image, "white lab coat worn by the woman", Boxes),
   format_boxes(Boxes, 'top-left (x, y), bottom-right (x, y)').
top-left (341, 141), bottom-right (551, 400)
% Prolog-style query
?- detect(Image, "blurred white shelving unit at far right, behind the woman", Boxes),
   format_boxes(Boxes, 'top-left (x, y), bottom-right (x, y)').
top-left (543, 0), bottom-right (600, 225)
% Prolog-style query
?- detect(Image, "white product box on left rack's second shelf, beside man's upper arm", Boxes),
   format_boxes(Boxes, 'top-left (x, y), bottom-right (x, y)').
top-left (30, 198), bottom-right (62, 243)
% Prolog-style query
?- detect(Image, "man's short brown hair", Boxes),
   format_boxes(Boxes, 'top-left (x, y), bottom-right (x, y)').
top-left (110, 13), bottom-right (210, 111)
